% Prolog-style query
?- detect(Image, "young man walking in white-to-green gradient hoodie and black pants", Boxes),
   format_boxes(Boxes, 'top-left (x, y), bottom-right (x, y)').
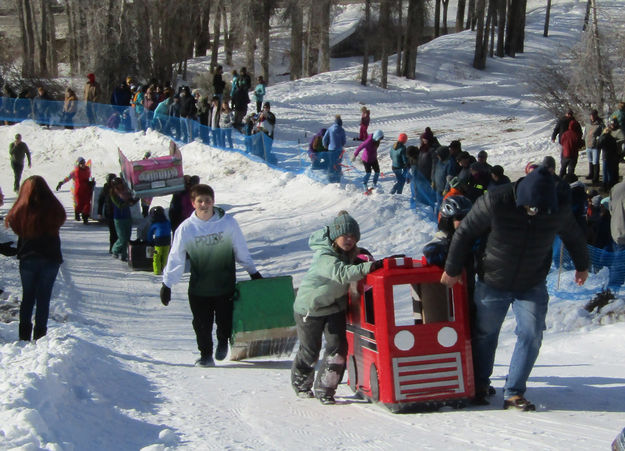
top-left (160, 184), bottom-right (262, 367)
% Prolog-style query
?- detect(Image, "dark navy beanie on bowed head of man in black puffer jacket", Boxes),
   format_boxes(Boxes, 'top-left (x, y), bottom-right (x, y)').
top-left (516, 166), bottom-right (558, 213)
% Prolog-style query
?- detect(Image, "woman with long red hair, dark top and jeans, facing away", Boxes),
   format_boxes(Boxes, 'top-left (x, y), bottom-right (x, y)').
top-left (4, 175), bottom-right (66, 341)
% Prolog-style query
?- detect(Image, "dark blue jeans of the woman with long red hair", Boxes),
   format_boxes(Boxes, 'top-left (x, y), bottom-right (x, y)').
top-left (20, 257), bottom-right (60, 335)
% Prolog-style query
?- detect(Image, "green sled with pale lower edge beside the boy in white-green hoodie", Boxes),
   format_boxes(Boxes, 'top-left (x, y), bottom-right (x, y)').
top-left (230, 276), bottom-right (297, 360)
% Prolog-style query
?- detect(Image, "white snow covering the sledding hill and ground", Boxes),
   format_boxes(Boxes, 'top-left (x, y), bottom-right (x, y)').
top-left (0, 2), bottom-right (625, 450)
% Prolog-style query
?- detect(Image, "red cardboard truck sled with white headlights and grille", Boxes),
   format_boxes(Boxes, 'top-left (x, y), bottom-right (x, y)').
top-left (347, 258), bottom-right (475, 412)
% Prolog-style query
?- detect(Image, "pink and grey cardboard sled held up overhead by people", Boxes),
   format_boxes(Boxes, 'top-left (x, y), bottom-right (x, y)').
top-left (118, 141), bottom-right (184, 197)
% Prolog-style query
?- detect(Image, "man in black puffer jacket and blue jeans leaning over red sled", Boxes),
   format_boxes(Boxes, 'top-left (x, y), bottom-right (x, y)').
top-left (441, 166), bottom-right (589, 410)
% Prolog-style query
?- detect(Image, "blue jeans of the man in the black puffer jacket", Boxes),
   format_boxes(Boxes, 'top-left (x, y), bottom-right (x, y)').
top-left (472, 281), bottom-right (549, 399)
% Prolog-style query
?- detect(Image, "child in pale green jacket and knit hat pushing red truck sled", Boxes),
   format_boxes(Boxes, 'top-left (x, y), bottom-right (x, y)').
top-left (291, 211), bottom-right (382, 405)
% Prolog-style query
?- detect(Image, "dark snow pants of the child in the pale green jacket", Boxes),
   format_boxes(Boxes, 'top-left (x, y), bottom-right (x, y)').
top-left (291, 312), bottom-right (347, 398)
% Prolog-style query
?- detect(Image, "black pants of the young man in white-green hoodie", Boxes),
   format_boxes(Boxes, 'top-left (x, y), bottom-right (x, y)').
top-left (189, 293), bottom-right (234, 357)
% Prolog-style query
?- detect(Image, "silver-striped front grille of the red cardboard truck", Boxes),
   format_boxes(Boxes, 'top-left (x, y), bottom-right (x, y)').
top-left (393, 352), bottom-right (465, 401)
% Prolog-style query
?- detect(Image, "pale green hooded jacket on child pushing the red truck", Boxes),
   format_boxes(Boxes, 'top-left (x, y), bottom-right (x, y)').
top-left (293, 227), bottom-right (373, 316)
